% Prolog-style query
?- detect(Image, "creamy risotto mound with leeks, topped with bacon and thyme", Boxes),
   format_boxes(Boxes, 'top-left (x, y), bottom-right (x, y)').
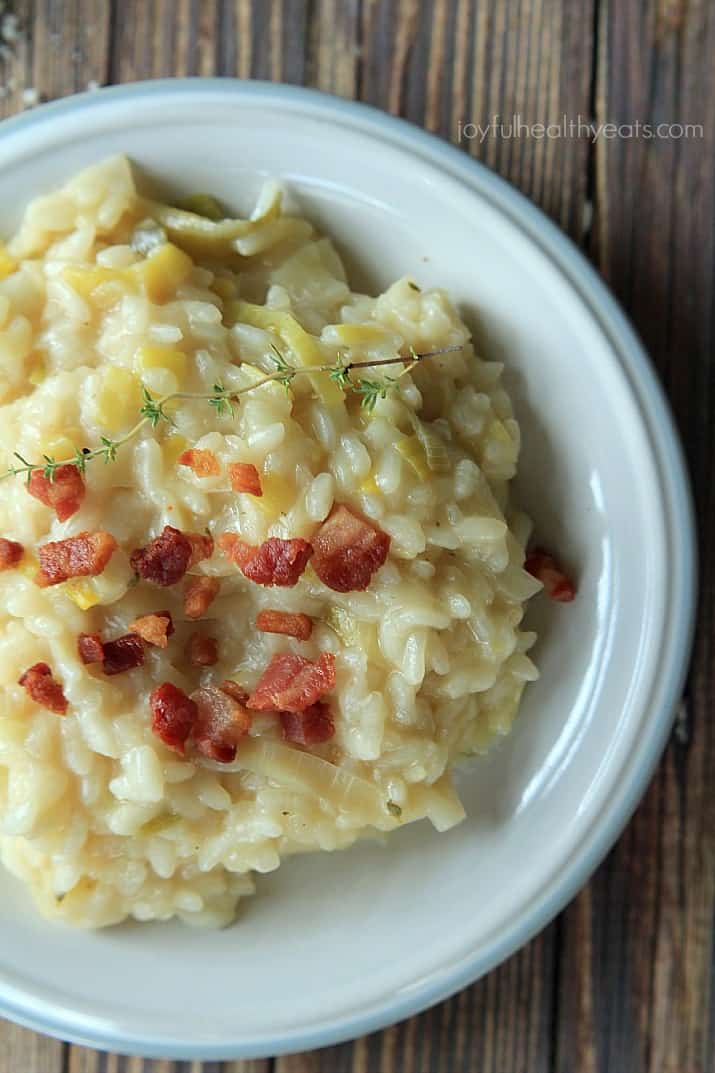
top-left (0, 158), bottom-right (541, 927)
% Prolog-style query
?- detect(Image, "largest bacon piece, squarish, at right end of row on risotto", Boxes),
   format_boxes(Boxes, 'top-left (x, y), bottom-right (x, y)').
top-left (312, 505), bottom-right (390, 592)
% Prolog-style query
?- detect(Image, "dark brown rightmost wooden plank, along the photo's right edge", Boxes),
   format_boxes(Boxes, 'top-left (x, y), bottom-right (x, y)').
top-left (556, 0), bottom-right (715, 1073)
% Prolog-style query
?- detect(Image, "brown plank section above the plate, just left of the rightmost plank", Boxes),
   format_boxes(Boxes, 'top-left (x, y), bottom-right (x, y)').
top-left (352, 0), bottom-right (594, 239)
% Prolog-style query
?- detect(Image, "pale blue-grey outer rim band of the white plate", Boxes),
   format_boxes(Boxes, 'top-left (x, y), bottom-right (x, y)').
top-left (0, 77), bottom-right (697, 1060)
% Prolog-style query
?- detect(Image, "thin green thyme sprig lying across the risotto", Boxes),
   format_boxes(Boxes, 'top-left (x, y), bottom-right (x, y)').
top-left (0, 347), bottom-right (462, 482)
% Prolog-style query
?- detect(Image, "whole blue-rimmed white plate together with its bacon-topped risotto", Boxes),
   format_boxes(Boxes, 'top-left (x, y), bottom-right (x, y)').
top-left (0, 79), bottom-right (694, 1058)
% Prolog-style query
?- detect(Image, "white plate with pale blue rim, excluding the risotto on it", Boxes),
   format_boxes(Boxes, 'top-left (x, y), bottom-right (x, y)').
top-left (0, 80), bottom-right (695, 1058)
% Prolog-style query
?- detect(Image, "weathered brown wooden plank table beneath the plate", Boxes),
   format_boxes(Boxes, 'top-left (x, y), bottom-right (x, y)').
top-left (0, 0), bottom-right (715, 1073)
